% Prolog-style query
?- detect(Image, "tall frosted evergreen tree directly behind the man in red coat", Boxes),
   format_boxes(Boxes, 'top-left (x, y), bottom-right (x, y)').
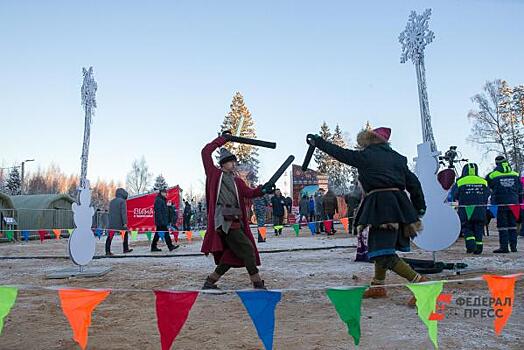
top-left (220, 92), bottom-right (259, 184)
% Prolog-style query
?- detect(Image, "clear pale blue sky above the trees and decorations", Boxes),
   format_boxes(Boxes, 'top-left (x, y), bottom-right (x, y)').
top-left (0, 0), bottom-right (524, 194)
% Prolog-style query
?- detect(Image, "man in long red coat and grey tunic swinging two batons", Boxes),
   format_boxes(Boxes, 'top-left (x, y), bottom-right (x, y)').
top-left (201, 132), bottom-right (272, 289)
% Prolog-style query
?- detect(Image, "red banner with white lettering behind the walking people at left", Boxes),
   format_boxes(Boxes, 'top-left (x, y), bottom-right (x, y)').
top-left (127, 186), bottom-right (182, 230)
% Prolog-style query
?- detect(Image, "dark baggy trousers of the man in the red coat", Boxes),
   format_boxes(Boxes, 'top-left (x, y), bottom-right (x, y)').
top-left (215, 228), bottom-right (258, 276)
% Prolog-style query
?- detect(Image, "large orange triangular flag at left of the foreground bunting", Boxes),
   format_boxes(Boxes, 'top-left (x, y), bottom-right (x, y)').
top-left (58, 289), bottom-right (111, 349)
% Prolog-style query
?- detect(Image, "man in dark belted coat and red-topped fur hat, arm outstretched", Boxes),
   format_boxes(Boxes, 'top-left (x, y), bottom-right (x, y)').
top-left (306, 128), bottom-right (427, 298)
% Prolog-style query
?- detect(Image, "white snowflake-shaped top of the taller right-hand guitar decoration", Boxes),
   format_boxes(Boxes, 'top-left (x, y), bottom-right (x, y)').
top-left (398, 9), bottom-right (435, 64)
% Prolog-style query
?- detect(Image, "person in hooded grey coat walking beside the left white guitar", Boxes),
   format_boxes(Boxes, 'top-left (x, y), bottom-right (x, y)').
top-left (106, 188), bottom-right (133, 256)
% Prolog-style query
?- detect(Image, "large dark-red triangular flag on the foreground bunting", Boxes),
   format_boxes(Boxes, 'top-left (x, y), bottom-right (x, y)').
top-left (155, 290), bottom-right (198, 350)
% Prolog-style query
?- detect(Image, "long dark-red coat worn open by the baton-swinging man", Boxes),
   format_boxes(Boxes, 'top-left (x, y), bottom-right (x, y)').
top-left (201, 136), bottom-right (264, 267)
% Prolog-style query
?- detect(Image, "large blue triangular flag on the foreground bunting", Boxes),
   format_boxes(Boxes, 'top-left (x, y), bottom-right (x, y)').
top-left (237, 291), bottom-right (282, 350)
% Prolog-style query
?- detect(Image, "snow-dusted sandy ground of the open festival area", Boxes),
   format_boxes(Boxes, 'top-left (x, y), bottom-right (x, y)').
top-left (0, 224), bottom-right (524, 350)
